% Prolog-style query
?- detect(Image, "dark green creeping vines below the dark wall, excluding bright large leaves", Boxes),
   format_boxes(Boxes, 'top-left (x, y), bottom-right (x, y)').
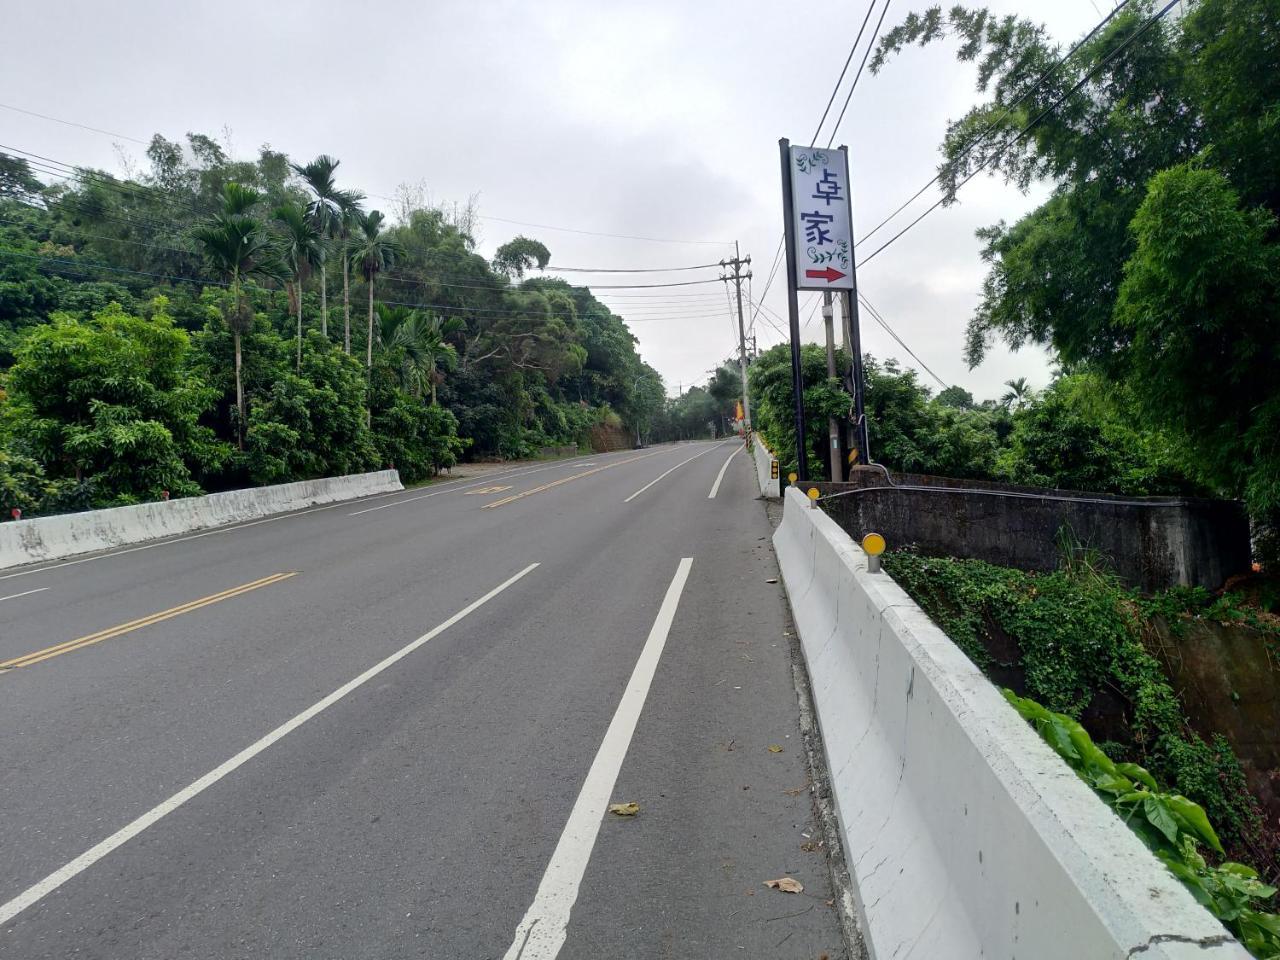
top-left (884, 552), bottom-right (1264, 869)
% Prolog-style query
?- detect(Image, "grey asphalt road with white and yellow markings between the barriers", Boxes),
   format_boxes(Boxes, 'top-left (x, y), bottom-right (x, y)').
top-left (0, 443), bottom-right (844, 960)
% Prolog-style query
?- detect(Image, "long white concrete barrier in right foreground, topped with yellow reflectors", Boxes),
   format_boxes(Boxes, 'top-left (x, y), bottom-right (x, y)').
top-left (773, 488), bottom-right (1248, 960)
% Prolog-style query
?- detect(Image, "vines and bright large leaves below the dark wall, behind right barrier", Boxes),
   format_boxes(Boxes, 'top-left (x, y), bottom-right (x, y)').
top-left (884, 549), bottom-right (1280, 957)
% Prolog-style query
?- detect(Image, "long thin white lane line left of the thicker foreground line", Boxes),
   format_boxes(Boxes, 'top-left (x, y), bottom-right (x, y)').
top-left (0, 563), bottom-right (539, 927)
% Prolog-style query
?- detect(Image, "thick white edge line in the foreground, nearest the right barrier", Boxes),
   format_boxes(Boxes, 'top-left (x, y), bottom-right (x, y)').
top-left (503, 557), bottom-right (694, 960)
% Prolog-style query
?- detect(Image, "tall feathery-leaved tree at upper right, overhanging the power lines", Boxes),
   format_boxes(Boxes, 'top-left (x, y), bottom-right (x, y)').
top-left (873, 0), bottom-right (1280, 559)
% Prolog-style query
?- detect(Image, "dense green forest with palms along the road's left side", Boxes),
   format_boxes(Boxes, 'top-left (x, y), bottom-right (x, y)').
top-left (0, 144), bottom-right (670, 518)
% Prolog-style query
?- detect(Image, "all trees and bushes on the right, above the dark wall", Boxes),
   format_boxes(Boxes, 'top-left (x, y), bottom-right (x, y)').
top-left (753, 0), bottom-right (1280, 564)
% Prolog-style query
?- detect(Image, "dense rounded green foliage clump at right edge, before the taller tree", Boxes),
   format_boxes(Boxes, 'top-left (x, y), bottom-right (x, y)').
top-left (1115, 165), bottom-right (1280, 515)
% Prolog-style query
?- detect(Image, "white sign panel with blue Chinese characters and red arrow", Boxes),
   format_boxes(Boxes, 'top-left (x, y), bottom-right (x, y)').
top-left (791, 146), bottom-right (854, 291)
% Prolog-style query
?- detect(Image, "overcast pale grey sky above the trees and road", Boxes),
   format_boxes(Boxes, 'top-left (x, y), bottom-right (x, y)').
top-left (0, 0), bottom-right (1107, 399)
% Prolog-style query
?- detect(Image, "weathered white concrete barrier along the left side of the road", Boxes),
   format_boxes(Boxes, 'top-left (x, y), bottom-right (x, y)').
top-left (0, 470), bottom-right (404, 570)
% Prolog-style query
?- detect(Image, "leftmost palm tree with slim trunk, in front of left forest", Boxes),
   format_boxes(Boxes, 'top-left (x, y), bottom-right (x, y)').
top-left (192, 183), bottom-right (288, 449)
